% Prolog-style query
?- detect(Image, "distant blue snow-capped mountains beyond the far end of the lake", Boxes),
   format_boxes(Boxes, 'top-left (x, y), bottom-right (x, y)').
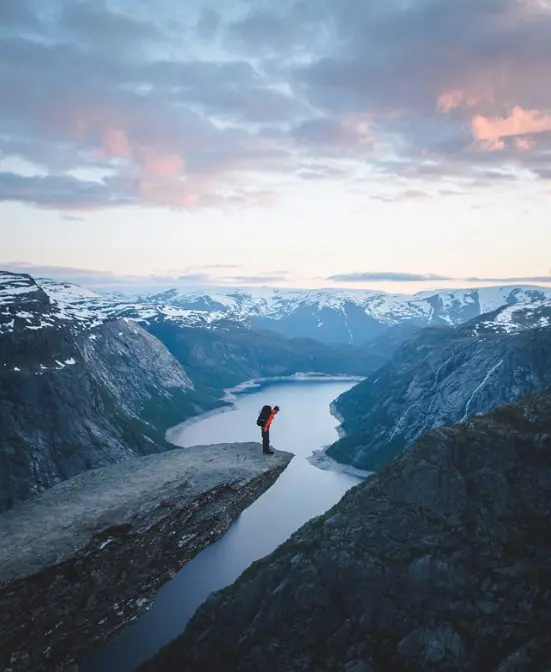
top-left (127, 286), bottom-right (551, 345)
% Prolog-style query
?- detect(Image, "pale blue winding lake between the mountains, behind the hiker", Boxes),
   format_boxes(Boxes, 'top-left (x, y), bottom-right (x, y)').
top-left (80, 379), bottom-right (361, 672)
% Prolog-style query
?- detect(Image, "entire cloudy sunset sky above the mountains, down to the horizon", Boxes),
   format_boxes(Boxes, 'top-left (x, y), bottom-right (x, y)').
top-left (0, 0), bottom-right (551, 293)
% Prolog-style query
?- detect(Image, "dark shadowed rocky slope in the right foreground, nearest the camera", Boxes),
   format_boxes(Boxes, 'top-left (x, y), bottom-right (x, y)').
top-left (141, 396), bottom-right (551, 672)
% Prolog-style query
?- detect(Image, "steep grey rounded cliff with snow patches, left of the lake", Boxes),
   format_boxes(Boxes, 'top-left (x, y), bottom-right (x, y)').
top-left (0, 273), bottom-right (215, 511)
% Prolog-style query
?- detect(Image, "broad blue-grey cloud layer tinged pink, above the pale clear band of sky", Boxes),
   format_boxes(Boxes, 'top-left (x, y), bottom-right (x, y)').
top-left (0, 0), bottom-right (551, 210)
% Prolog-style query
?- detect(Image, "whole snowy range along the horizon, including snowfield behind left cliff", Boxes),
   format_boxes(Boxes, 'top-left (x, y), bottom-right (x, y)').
top-left (11, 270), bottom-right (551, 346)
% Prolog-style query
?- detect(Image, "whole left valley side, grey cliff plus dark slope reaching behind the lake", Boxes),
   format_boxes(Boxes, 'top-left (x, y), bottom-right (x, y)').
top-left (0, 273), bottom-right (384, 511)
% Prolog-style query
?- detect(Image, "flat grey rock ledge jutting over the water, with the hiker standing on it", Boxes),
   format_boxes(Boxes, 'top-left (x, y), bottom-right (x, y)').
top-left (0, 443), bottom-right (292, 672)
